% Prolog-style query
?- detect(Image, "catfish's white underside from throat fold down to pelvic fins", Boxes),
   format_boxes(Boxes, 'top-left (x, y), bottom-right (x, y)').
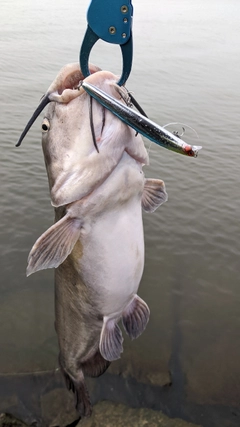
top-left (72, 153), bottom-right (144, 316)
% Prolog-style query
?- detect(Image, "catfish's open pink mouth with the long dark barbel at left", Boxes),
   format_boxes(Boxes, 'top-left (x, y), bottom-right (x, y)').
top-left (16, 63), bottom-right (100, 147)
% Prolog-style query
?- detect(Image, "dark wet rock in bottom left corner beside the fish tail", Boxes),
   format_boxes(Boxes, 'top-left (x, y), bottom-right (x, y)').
top-left (0, 370), bottom-right (79, 427)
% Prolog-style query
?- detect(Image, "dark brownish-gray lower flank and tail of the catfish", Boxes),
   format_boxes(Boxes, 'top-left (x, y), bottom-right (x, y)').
top-left (55, 227), bottom-right (110, 417)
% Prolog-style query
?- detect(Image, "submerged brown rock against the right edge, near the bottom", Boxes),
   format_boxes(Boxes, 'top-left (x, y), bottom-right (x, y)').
top-left (183, 332), bottom-right (240, 408)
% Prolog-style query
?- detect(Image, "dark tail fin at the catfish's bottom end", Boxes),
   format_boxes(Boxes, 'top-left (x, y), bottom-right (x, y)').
top-left (59, 356), bottom-right (92, 417)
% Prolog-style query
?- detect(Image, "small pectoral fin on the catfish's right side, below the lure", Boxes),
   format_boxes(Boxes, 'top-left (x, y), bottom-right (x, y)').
top-left (142, 179), bottom-right (168, 212)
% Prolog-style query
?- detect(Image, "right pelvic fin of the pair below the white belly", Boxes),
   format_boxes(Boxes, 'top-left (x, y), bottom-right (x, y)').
top-left (122, 295), bottom-right (150, 339)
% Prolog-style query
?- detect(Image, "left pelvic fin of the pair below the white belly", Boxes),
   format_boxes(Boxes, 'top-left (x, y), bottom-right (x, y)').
top-left (99, 317), bottom-right (123, 362)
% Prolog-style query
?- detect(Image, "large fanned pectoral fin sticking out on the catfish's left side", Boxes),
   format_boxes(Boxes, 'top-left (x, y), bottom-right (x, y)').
top-left (27, 215), bottom-right (81, 276)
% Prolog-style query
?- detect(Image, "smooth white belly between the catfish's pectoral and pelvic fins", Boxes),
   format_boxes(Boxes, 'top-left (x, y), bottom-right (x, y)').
top-left (79, 203), bottom-right (144, 316)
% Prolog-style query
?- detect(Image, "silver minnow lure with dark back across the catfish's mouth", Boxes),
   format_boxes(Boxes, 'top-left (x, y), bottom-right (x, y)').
top-left (82, 81), bottom-right (202, 157)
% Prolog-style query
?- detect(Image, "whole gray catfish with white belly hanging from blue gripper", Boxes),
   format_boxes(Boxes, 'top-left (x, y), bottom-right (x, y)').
top-left (23, 64), bottom-right (167, 416)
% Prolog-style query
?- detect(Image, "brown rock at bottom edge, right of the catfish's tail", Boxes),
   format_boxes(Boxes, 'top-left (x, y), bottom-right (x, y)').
top-left (77, 401), bottom-right (201, 427)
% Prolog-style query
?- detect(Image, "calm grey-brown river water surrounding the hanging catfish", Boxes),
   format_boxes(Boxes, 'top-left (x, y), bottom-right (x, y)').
top-left (0, 0), bottom-right (240, 426)
